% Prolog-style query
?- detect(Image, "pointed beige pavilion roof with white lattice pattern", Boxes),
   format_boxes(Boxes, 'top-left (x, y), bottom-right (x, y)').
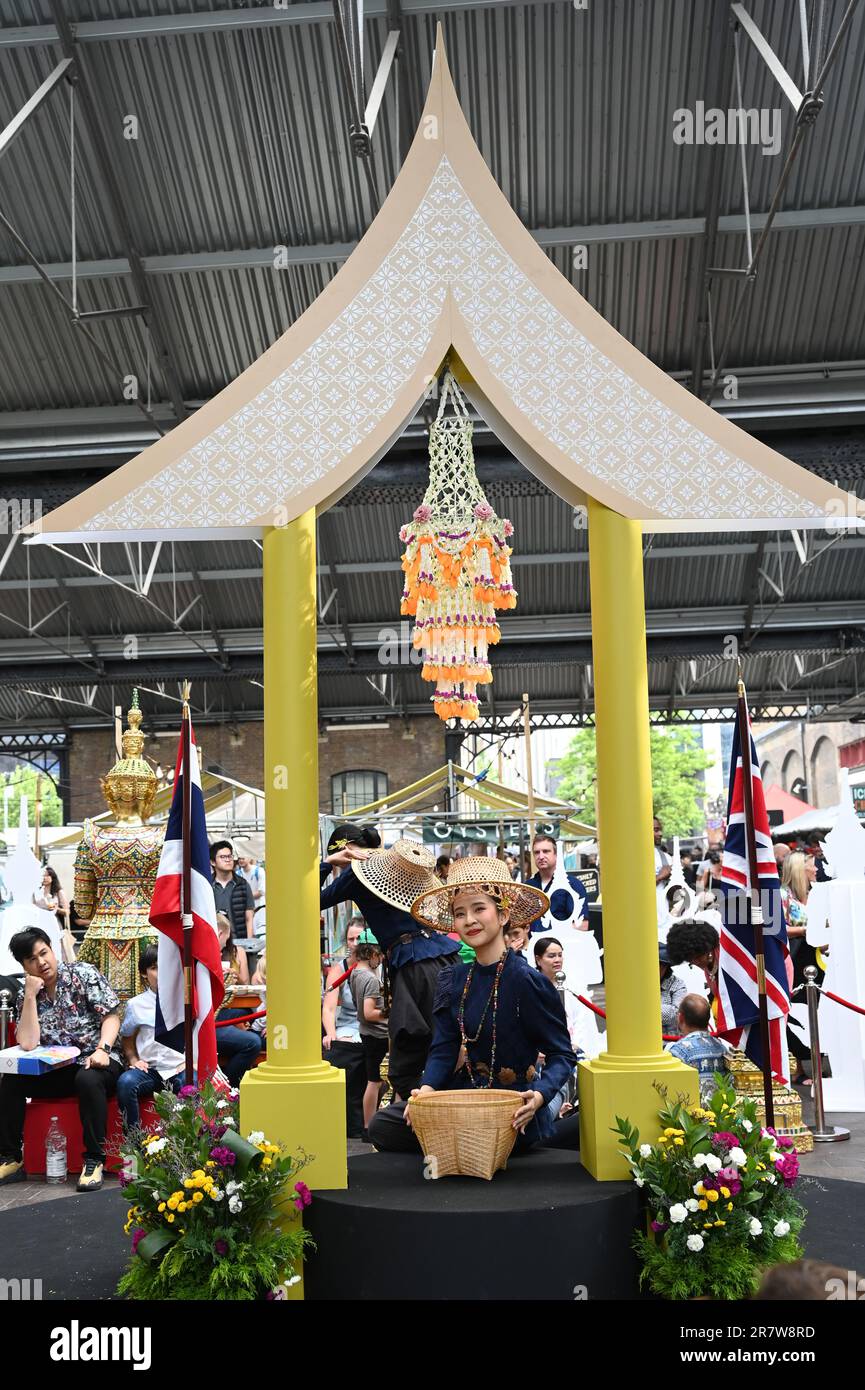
top-left (33, 29), bottom-right (848, 542)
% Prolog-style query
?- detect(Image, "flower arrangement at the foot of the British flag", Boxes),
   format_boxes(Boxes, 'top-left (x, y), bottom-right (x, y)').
top-left (615, 1073), bottom-right (805, 1298)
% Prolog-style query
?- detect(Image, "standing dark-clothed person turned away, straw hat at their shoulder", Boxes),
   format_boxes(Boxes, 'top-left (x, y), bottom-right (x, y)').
top-left (320, 824), bottom-right (459, 1099)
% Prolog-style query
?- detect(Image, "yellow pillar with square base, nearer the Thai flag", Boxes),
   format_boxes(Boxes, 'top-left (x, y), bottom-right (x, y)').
top-left (241, 510), bottom-right (348, 1256)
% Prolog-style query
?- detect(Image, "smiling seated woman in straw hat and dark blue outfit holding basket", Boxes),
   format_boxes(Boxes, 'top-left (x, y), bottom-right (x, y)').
top-left (370, 856), bottom-right (579, 1152)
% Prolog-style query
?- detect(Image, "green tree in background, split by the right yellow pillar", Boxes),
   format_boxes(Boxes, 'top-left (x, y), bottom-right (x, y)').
top-left (558, 726), bottom-right (712, 835)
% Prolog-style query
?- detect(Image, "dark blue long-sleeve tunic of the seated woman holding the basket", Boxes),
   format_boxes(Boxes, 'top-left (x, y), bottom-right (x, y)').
top-left (421, 951), bottom-right (577, 1143)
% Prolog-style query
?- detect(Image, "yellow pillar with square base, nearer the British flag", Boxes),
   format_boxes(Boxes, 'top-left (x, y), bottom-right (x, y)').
top-left (580, 499), bottom-right (700, 1179)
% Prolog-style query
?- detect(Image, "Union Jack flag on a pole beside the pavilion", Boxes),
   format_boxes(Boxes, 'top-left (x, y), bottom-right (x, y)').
top-left (716, 713), bottom-right (790, 1081)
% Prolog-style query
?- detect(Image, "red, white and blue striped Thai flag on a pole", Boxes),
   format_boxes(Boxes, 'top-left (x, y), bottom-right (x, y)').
top-left (150, 724), bottom-right (225, 1083)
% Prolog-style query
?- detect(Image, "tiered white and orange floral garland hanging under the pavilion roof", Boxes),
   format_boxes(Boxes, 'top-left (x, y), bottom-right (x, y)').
top-left (399, 371), bottom-right (516, 720)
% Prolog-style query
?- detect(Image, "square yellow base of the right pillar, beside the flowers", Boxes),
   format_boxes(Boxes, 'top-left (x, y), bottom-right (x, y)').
top-left (579, 1052), bottom-right (700, 1183)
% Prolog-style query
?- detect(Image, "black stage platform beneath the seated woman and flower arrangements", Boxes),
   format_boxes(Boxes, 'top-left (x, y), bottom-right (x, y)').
top-left (0, 1151), bottom-right (865, 1301)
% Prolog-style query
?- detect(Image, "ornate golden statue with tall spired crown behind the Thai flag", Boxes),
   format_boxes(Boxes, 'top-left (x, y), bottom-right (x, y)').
top-left (75, 691), bottom-right (165, 999)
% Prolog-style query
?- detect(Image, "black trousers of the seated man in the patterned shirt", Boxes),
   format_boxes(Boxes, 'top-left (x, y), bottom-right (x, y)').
top-left (0, 1058), bottom-right (122, 1163)
